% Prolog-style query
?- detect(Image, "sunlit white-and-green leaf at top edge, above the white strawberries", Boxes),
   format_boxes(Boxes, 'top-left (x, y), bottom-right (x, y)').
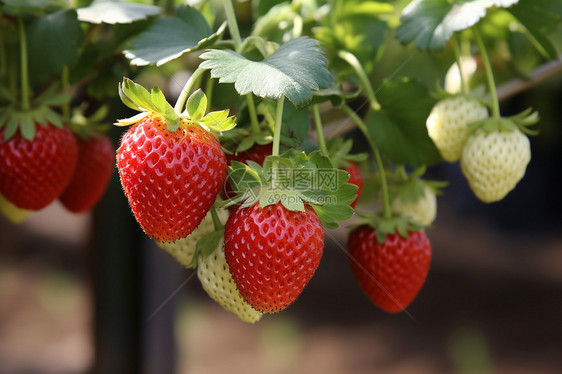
top-left (396, 0), bottom-right (518, 51)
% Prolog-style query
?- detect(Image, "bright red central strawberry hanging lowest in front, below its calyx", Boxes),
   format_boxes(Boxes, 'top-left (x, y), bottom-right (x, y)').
top-left (224, 203), bottom-right (324, 313)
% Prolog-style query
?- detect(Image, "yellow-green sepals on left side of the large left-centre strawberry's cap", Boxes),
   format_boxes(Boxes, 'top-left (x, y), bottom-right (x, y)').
top-left (116, 78), bottom-right (180, 132)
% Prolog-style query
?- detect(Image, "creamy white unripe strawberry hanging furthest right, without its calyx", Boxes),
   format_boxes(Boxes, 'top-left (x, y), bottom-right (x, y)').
top-left (461, 129), bottom-right (531, 203)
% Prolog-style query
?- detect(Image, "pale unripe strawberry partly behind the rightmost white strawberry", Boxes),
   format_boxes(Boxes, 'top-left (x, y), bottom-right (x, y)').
top-left (426, 96), bottom-right (488, 162)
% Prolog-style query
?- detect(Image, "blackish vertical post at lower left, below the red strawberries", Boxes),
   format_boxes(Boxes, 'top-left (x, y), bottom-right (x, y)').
top-left (92, 169), bottom-right (142, 374)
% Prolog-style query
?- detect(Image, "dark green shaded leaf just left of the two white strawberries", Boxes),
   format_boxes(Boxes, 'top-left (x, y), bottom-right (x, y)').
top-left (367, 78), bottom-right (441, 168)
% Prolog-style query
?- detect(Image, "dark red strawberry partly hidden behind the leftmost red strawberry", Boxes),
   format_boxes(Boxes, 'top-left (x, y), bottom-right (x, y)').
top-left (59, 135), bottom-right (115, 213)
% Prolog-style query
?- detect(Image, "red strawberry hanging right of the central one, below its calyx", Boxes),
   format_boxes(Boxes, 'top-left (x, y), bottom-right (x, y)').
top-left (347, 225), bottom-right (431, 313)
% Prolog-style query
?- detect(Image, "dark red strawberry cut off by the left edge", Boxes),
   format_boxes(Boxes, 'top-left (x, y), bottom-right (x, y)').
top-left (0, 124), bottom-right (78, 210)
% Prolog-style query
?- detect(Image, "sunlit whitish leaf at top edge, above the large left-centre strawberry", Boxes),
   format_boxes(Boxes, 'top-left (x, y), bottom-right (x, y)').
top-left (76, 1), bottom-right (161, 25)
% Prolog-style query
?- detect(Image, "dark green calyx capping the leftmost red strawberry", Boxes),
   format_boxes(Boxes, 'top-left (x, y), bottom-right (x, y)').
top-left (0, 87), bottom-right (70, 141)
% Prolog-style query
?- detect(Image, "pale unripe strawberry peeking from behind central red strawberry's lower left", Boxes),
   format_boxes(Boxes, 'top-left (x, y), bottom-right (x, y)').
top-left (197, 240), bottom-right (262, 323)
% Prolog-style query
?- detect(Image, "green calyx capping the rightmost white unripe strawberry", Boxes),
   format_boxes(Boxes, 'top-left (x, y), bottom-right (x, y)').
top-left (468, 108), bottom-right (540, 135)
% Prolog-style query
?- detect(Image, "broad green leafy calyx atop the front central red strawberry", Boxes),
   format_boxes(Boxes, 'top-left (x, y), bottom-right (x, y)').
top-left (225, 149), bottom-right (357, 228)
